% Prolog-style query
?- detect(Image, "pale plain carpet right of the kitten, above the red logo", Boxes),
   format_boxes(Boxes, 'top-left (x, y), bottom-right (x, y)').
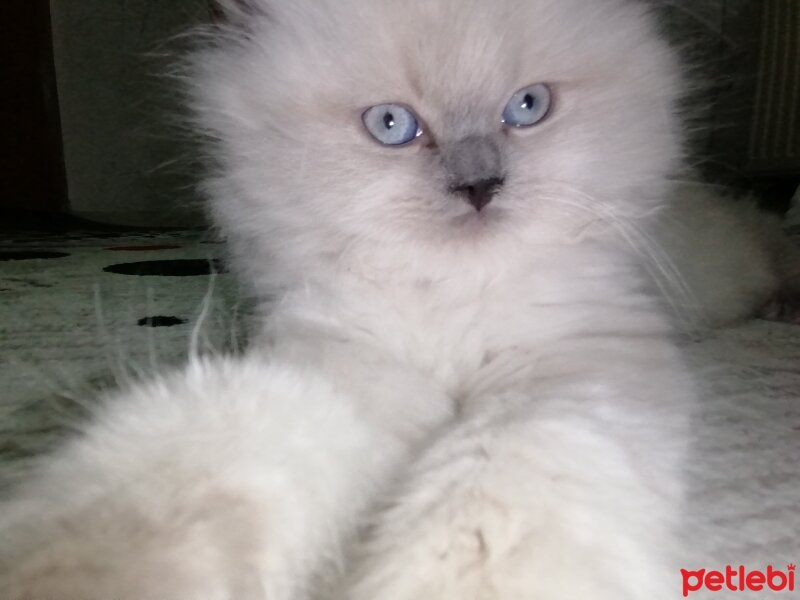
top-left (682, 321), bottom-right (800, 584)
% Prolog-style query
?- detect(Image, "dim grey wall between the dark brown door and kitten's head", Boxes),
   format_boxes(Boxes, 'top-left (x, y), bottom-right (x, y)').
top-left (51, 0), bottom-right (207, 225)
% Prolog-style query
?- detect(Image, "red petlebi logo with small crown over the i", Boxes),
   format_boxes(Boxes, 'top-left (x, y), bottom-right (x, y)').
top-left (681, 564), bottom-right (797, 598)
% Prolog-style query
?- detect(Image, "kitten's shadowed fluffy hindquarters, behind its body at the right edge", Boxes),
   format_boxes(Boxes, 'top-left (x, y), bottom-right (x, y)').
top-left (647, 184), bottom-right (800, 330)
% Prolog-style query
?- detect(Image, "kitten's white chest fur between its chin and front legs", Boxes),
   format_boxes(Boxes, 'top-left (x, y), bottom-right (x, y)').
top-left (268, 239), bottom-right (666, 396)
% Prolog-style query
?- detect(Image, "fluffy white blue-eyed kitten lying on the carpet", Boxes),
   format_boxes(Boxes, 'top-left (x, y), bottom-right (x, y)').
top-left (0, 0), bottom-right (783, 600)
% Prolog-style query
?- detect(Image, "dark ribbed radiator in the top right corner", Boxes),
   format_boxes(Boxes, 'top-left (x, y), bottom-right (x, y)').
top-left (746, 0), bottom-right (800, 175)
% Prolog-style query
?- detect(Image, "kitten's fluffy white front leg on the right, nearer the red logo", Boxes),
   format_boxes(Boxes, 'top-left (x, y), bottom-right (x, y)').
top-left (339, 384), bottom-right (683, 600)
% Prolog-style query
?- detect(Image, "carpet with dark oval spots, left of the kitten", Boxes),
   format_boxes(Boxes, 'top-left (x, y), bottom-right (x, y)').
top-left (0, 231), bottom-right (244, 472)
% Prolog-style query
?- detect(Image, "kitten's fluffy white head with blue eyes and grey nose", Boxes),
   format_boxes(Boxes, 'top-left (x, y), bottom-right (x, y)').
top-left (192, 0), bottom-right (681, 287)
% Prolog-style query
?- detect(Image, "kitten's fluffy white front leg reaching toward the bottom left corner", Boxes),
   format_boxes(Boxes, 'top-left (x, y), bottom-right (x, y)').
top-left (0, 352), bottom-right (449, 600)
